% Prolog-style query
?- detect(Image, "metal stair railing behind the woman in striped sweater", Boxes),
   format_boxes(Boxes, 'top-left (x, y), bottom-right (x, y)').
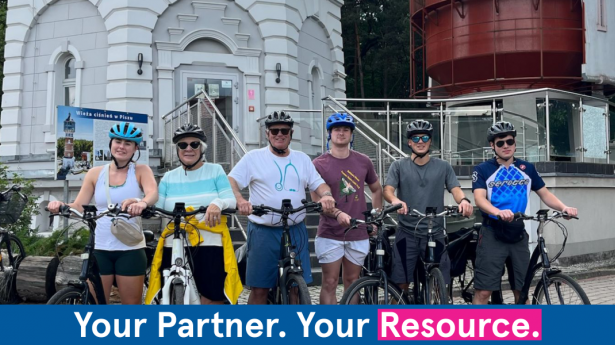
top-left (162, 90), bottom-right (248, 239)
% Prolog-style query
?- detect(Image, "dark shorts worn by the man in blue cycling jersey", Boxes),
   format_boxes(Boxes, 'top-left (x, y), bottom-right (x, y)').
top-left (474, 225), bottom-right (530, 291)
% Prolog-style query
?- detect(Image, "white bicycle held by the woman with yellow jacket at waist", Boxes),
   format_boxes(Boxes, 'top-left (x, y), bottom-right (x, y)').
top-left (141, 202), bottom-right (235, 305)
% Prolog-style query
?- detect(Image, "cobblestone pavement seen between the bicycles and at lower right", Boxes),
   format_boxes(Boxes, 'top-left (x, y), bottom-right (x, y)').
top-left (239, 275), bottom-right (615, 304)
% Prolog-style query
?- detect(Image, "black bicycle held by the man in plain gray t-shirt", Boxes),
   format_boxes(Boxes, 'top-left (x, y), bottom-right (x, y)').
top-left (410, 206), bottom-right (459, 305)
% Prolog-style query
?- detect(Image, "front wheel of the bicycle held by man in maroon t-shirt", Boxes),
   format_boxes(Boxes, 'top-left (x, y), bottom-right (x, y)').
top-left (340, 277), bottom-right (407, 305)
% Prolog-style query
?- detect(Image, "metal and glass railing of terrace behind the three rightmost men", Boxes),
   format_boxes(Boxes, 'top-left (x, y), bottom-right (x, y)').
top-left (322, 88), bottom-right (615, 165)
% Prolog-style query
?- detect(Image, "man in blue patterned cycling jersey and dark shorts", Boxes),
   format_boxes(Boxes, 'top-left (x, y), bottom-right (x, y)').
top-left (472, 121), bottom-right (577, 304)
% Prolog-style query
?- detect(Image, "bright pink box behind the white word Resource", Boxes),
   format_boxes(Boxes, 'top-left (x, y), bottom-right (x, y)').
top-left (378, 309), bottom-right (542, 340)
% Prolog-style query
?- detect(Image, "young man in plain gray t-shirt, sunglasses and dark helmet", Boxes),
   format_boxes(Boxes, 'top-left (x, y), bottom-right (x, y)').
top-left (384, 120), bottom-right (473, 290)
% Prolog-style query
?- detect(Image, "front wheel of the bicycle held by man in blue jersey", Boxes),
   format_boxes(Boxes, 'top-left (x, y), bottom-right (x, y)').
top-left (532, 273), bottom-right (591, 305)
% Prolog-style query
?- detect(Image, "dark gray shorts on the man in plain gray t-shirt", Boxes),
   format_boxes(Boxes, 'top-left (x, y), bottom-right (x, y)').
top-left (391, 228), bottom-right (451, 284)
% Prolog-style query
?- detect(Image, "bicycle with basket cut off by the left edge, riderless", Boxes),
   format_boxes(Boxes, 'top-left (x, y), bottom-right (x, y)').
top-left (0, 185), bottom-right (28, 304)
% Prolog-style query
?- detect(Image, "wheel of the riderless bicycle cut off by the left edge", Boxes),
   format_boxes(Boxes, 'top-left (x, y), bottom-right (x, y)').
top-left (0, 234), bottom-right (26, 304)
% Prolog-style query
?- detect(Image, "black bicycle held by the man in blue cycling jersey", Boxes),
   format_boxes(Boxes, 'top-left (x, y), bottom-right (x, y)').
top-left (515, 210), bottom-right (591, 305)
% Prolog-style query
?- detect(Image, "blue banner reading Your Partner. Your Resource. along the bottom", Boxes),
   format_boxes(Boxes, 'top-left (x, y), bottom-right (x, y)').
top-left (0, 305), bottom-right (615, 345)
